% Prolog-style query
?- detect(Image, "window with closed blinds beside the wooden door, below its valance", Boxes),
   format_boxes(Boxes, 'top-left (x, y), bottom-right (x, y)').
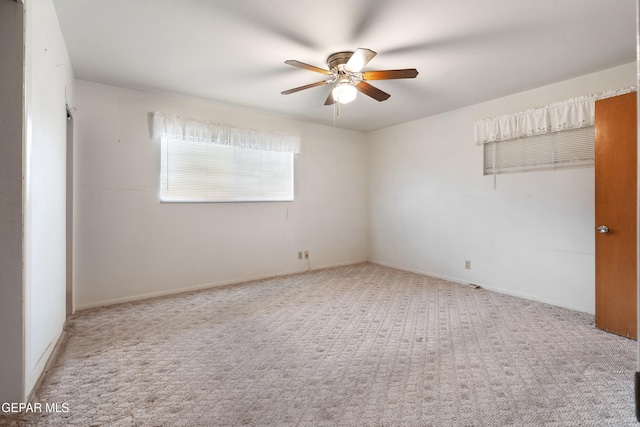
top-left (484, 126), bottom-right (595, 175)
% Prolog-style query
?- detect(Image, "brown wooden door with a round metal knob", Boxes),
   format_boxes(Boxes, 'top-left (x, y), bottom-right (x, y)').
top-left (595, 92), bottom-right (637, 339)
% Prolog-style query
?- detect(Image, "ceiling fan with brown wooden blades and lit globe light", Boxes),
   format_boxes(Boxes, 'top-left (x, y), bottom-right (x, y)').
top-left (281, 48), bottom-right (418, 105)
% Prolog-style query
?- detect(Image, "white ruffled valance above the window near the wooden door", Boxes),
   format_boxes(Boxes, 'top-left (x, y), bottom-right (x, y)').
top-left (474, 87), bottom-right (636, 144)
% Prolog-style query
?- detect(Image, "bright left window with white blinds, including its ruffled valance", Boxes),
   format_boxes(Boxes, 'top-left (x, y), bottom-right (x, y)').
top-left (150, 111), bottom-right (300, 202)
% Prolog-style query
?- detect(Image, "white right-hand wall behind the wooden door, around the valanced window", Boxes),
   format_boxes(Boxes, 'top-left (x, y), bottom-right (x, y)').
top-left (368, 63), bottom-right (636, 313)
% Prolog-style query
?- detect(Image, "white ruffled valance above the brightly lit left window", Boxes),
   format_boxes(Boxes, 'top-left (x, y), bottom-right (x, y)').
top-left (151, 111), bottom-right (300, 154)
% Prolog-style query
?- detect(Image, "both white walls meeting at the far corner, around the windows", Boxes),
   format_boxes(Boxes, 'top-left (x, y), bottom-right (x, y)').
top-left (75, 64), bottom-right (635, 313)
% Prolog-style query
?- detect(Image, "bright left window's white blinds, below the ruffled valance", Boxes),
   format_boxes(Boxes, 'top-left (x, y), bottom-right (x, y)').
top-left (160, 137), bottom-right (294, 202)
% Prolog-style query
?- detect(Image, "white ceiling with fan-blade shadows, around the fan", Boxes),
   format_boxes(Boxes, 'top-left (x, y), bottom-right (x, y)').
top-left (53, 0), bottom-right (636, 132)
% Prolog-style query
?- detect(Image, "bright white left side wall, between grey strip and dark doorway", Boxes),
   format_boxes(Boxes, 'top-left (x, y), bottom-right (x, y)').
top-left (23, 0), bottom-right (74, 398)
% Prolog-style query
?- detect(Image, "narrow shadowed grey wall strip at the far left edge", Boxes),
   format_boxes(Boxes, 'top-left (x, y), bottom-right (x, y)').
top-left (0, 1), bottom-right (24, 408)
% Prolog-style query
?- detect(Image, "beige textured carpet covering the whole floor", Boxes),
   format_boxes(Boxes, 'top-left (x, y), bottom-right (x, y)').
top-left (0, 264), bottom-right (636, 427)
